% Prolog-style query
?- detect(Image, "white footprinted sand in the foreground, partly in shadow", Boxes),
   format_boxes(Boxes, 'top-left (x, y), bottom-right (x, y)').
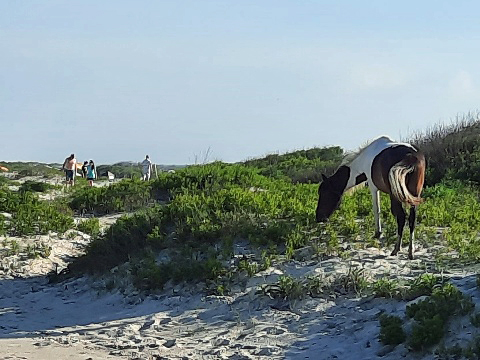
top-left (0, 236), bottom-right (480, 359)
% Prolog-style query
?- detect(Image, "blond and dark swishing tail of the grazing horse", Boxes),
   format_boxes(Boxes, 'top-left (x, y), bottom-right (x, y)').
top-left (388, 153), bottom-right (424, 206)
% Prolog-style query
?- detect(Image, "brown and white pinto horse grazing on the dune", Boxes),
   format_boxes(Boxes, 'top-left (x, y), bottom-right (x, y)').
top-left (316, 136), bottom-right (425, 259)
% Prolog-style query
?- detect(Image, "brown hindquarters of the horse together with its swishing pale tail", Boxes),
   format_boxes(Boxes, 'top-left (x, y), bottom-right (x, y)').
top-left (371, 145), bottom-right (425, 205)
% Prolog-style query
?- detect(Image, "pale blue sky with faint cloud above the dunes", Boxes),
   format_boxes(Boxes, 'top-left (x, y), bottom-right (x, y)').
top-left (0, 0), bottom-right (480, 164)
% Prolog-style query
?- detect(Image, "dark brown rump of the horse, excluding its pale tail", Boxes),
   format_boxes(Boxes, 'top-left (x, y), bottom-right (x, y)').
top-left (371, 145), bottom-right (425, 196)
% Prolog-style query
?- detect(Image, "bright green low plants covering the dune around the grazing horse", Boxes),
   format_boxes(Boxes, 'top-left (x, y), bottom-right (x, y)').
top-left (65, 149), bottom-right (480, 297)
